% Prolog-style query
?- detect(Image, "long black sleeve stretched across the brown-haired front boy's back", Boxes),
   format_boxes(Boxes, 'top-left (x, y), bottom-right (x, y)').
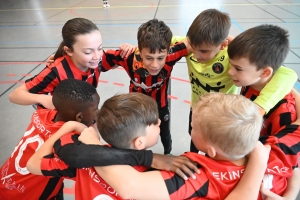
top-left (54, 134), bottom-right (153, 168)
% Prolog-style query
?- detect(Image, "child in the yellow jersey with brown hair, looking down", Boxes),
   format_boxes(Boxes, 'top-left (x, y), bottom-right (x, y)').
top-left (172, 9), bottom-right (297, 152)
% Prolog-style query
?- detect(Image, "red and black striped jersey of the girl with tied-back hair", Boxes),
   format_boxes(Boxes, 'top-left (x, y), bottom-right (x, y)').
top-left (25, 55), bottom-right (101, 94)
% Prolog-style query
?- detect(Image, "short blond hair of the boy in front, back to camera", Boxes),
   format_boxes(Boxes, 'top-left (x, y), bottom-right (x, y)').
top-left (193, 92), bottom-right (263, 160)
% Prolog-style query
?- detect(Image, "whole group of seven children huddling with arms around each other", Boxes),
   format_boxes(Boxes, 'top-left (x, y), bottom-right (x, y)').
top-left (0, 9), bottom-right (300, 199)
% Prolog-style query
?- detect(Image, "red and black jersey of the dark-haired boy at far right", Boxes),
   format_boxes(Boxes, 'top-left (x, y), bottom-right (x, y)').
top-left (241, 86), bottom-right (297, 135)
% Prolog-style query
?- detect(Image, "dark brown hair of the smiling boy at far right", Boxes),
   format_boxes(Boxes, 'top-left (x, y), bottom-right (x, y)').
top-left (228, 24), bottom-right (289, 72)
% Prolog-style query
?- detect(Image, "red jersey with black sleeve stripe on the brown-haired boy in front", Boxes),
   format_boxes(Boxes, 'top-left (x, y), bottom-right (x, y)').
top-left (41, 138), bottom-right (147, 200)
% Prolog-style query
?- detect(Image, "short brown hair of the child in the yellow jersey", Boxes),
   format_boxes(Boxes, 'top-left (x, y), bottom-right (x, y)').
top-left (187, 9), bottom-right (231, 47)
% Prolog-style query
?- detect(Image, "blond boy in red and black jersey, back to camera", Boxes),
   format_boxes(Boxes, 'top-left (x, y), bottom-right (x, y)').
top-left (67, 93), bottom-right (300, 200)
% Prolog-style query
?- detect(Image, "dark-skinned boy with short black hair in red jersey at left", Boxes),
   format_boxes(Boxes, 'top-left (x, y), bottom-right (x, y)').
top-left (0, 79), bottom-right (195, 199)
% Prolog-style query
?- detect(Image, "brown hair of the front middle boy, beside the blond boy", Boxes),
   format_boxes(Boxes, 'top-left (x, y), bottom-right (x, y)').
top-left (97, 92), bottom-right (159, 149)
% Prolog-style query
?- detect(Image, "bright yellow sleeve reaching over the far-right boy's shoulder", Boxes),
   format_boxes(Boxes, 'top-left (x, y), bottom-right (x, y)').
top-left (254, 66), bottom-right (298, 113)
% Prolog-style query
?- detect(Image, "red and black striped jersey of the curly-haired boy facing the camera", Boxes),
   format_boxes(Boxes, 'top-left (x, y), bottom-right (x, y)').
top-left (102, 43), bottom-right (188, 108)
